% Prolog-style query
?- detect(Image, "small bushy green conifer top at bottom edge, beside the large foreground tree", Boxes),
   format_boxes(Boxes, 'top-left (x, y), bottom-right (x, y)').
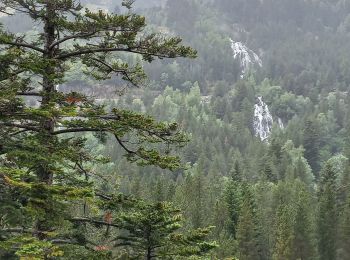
top-left (116, 201), bottom-right (216, 260)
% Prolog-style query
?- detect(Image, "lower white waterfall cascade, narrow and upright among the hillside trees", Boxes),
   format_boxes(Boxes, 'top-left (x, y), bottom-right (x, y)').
top-left (254, 97), bottom-right (274, 141)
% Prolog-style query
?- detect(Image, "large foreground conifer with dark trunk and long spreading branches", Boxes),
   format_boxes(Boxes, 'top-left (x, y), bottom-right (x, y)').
top-left (0, 0), bottom-right (196, 258)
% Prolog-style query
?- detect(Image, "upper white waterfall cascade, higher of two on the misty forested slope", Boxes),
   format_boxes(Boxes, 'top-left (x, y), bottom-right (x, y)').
top-left (230, 38), bottom-right (262, 77)
